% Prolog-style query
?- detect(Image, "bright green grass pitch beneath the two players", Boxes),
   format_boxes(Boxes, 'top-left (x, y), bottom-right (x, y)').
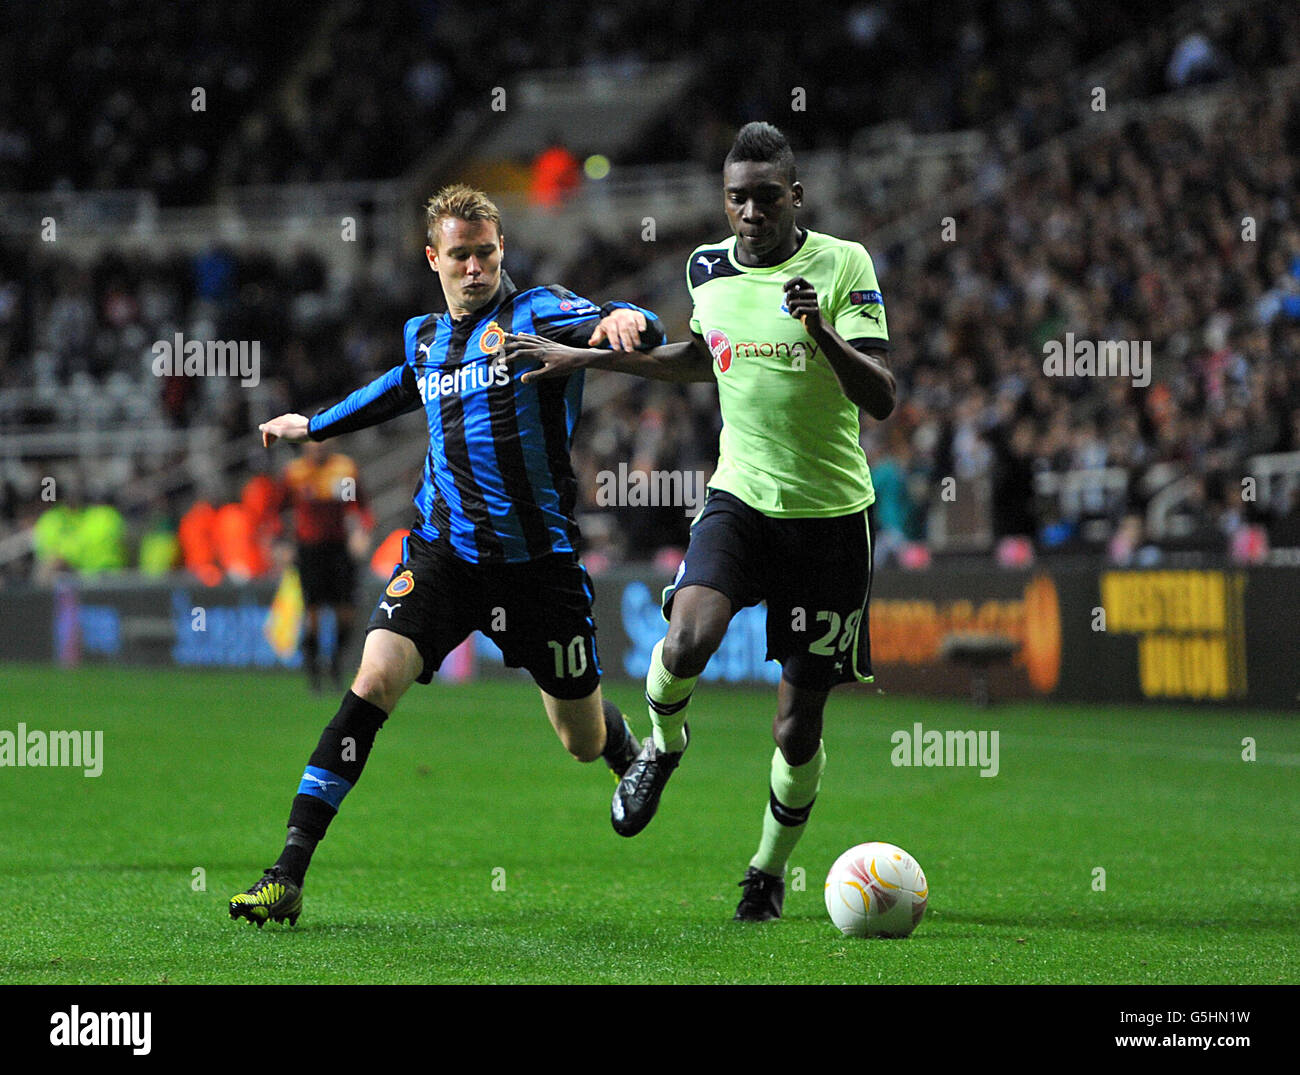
top-left (0, 666), bottom-right (1300, 984)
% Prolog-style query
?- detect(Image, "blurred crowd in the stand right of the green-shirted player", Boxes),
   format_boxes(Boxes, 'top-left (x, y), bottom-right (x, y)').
top-left (867, 76), bottom-right (1300, 564)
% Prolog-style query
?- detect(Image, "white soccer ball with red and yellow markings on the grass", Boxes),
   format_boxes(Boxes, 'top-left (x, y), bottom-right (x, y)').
top-left (826, 844), bottom-right (930, 937)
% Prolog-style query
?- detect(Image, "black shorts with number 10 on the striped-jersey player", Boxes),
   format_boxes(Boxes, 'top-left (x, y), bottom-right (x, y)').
top-left (365, 534), bottom-right (601, 698)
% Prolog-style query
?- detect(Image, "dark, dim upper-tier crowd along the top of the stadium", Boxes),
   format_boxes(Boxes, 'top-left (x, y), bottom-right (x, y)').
top-left (0, 0), bottom-right (1242, 197)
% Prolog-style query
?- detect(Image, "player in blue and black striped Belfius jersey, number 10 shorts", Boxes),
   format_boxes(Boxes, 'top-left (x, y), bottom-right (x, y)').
top-left (230, 185), bottom-right (663, 927)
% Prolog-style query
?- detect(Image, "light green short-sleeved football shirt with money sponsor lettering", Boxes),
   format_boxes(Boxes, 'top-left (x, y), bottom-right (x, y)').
top-left (686, 231), bottom-right (889, 519)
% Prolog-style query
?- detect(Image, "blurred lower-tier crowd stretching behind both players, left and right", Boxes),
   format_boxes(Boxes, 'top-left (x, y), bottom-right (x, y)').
top-left (0, 76), bottom-right (1300, 584)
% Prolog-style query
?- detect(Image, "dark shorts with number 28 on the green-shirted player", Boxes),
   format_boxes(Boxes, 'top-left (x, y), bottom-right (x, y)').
top-left (663, 489), bottom-right (872, 690)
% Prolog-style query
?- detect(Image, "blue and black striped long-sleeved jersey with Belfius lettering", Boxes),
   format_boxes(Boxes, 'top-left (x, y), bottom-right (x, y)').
top-left (309, 272), bottom-right (664, 563)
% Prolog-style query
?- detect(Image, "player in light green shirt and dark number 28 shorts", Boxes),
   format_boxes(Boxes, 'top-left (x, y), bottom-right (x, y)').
top-left (506, 123), bottom-right (896, 922)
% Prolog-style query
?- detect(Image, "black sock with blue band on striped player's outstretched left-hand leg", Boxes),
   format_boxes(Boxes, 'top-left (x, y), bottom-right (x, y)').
top-left (276, 690), bottom-right (389, 885)
